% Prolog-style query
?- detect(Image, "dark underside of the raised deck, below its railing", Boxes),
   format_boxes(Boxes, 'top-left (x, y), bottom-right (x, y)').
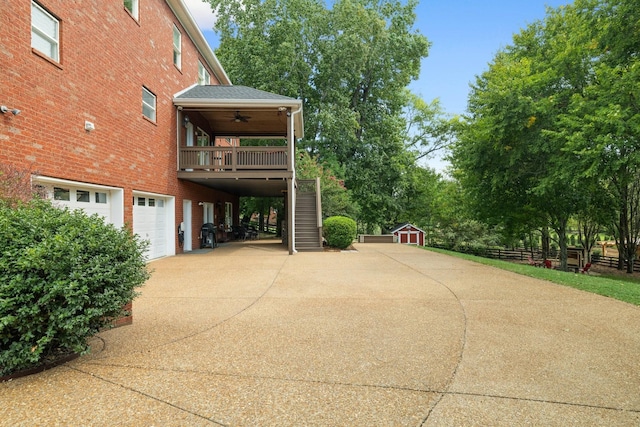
top-left (181, 178), bottom-right (287, 197)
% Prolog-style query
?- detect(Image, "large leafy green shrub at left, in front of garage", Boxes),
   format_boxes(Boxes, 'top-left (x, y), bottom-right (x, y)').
top-left (0, 200), bottom-right (149, 375)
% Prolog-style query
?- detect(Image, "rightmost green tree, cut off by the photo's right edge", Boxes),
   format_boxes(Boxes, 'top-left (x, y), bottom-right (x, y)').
top-left (559, 0), bottom-right (640, 273)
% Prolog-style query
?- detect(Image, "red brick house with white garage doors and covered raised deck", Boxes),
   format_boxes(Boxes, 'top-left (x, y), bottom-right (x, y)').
top-left (0, 0), bottom-right (320, 259)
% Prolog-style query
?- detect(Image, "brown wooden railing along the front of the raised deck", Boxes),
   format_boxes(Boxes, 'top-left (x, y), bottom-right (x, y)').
top-left (179, 147), bottom-right (289, 172)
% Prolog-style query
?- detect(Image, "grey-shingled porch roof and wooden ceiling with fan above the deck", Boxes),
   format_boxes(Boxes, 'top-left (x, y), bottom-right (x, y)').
top-left (173, 85), bottom-right (304, 138)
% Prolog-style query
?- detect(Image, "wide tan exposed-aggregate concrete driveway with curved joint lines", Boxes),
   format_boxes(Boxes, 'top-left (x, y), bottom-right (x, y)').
top-left (0, 241), bottom-right (640, 426)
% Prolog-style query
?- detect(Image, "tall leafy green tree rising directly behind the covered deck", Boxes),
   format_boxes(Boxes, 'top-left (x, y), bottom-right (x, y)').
top-left (209, 0), bottom-right (429, 231)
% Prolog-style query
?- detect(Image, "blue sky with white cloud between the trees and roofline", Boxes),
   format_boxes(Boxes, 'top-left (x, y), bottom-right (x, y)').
top-left (184, 0), bottom-right (572, 170)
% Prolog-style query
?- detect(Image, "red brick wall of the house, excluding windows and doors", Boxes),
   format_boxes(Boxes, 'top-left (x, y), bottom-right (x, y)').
top-left (0, 0), bottom-right (232, 252)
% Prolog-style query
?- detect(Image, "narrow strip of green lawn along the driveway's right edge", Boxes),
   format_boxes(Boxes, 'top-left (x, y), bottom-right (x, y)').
top-left (425, 248), bottom-right (640, 305)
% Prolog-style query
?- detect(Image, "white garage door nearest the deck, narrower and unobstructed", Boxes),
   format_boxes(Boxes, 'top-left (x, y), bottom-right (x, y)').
top-left (133, 195), bottom-right (168, 259)
